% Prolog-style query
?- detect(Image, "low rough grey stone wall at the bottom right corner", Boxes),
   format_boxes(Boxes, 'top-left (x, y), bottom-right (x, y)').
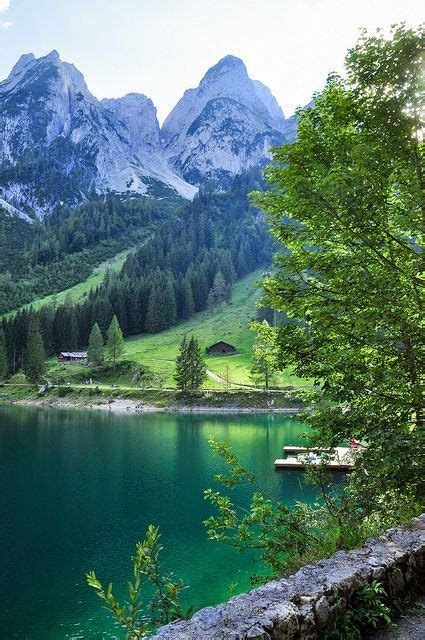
top-left (154, 514), bottom-right (425, 640)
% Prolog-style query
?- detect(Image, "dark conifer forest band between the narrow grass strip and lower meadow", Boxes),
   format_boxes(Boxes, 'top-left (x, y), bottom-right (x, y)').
top-left (3, 170), bottom-right (273, 372)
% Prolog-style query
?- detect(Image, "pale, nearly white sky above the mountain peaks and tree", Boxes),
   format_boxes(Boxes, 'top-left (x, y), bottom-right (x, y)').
top-left (0, 0), bottom-right (425, 121)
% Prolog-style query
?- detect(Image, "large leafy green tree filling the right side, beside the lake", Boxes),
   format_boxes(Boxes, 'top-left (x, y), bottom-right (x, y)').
top-left (255, 26), bottom-right (425, 504)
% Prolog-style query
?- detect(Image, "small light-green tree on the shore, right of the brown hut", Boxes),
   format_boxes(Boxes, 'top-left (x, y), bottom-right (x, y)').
top-left (251, 320), bottom-right (280, 391)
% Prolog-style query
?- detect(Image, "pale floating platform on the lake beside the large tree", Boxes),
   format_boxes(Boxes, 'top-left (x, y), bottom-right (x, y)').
top-left (274, 446), bottom-right (356, 472)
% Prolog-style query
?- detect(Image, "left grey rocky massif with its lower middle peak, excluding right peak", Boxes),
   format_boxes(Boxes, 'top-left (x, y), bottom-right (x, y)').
top-left (0, 51), bottom-right (196, 213)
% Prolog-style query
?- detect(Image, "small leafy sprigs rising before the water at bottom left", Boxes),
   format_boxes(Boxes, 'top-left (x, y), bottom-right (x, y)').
top-left (86, 525), bottom-right (184, 640)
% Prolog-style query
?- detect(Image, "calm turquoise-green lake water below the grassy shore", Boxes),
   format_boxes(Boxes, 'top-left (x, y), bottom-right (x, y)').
top-left (0, 407), bottom-right (313, 640)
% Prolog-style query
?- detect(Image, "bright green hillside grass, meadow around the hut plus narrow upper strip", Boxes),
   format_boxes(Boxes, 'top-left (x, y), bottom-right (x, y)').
top-left (17, 268), bottom-right (312, 391)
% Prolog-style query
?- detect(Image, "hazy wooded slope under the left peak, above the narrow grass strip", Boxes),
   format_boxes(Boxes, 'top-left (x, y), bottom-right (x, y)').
top-left (0, 195), bottom-right (176, 313)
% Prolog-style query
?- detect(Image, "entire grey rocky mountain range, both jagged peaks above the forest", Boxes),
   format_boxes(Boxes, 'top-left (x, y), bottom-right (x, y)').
top-left (0, 51), bottom-right (296, 215)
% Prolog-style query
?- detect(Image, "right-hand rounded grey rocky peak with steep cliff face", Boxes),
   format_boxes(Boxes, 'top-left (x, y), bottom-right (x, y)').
top-left (161, 56), bottom-right (285, 184)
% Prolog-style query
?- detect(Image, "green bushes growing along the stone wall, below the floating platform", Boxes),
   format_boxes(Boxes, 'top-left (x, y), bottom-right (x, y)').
top-left (204, 438), bottom-right (415, 583)
